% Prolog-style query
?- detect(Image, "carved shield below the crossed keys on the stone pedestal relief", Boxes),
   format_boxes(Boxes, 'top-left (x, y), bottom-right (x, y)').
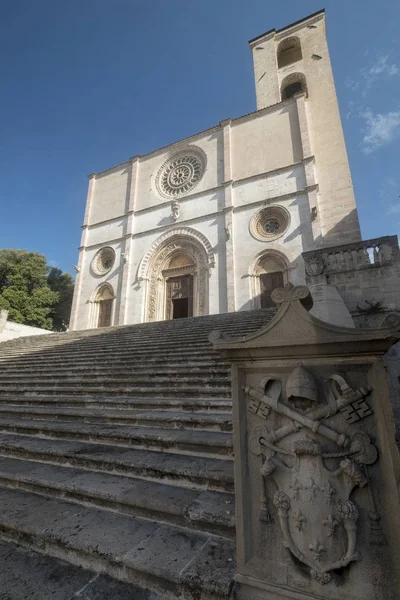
top-left (272, 440), bottom-right (358, 583)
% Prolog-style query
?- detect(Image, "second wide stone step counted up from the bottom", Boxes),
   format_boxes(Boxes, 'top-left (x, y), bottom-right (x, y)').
top-left (0, 488), bottom-right (235, 600)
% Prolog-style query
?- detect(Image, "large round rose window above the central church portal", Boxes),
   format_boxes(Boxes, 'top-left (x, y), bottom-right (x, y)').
top-left (155, 146), bottom-right (207, 198)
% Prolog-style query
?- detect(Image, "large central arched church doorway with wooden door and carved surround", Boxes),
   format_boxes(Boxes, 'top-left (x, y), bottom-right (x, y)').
top-left (138, 227), bottom-right (214, 321)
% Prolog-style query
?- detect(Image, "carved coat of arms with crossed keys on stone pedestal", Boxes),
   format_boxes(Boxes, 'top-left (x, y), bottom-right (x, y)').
top-left (245, 366), bottom-right (378, 585)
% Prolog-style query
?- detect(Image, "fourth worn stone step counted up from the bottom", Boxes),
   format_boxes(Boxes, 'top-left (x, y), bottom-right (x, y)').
top-left (0, 433), bottom-right (233, 492)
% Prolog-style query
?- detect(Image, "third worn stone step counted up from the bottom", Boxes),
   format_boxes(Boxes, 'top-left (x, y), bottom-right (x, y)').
top-left (0, 457), bottom-right (235, 538)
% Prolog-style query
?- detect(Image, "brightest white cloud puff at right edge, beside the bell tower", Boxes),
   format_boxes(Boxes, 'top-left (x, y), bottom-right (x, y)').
top-left (359, 109), bottom-right (400, 154)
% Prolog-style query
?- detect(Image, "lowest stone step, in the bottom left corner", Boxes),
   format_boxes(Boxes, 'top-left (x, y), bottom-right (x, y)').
top-left (0, 539), bottom-right (170, 600)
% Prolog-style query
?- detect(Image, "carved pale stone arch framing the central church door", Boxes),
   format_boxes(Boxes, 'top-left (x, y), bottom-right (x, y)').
top-left (138, 227), bottom-right (215, 322)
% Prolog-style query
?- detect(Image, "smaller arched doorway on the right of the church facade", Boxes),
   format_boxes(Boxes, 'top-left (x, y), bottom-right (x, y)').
top-left (249, 250), bottom-right (289, 308)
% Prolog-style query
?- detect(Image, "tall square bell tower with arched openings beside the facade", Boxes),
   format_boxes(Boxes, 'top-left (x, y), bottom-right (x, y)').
top-left (249, 10), bottom-right (360, 246)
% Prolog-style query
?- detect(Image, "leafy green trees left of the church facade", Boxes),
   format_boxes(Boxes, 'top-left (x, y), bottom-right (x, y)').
top-left (0, 249), bottom-right (72, 331)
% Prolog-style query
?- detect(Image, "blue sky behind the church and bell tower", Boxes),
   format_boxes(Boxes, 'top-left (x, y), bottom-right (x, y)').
top-left (0, 0), bottom-right (400, 272)
